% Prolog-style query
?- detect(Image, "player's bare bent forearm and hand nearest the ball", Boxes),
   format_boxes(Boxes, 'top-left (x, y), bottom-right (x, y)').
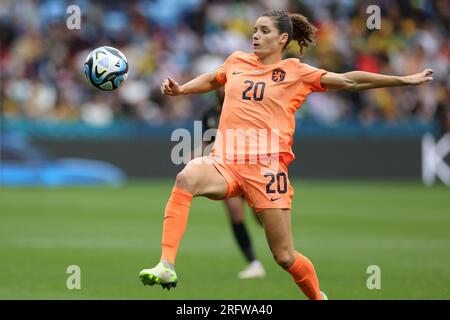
top-left (161, 72), bottom-right (223, 96)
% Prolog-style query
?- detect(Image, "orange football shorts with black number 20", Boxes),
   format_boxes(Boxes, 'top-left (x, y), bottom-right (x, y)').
top-left (208, 155), bottom-right (294, 212)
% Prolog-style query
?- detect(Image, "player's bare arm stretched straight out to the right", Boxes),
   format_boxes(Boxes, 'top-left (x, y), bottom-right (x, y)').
top-left (321, 69), bottom-right (433, 91)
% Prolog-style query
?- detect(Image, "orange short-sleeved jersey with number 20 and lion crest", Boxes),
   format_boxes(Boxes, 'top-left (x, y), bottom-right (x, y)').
top-left (211, 51), bottom-right (326, 163)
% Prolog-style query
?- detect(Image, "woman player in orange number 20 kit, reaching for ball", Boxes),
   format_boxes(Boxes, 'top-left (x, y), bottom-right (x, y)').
top-left (140, 11), bottom-right (433, 299)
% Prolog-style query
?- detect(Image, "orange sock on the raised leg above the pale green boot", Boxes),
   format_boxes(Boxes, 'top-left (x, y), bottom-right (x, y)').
top-left (161, 187), bottom-right (193, 265)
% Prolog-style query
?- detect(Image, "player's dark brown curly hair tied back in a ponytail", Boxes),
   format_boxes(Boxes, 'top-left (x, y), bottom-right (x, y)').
top-left (262, 10), bottom-right (317, 55)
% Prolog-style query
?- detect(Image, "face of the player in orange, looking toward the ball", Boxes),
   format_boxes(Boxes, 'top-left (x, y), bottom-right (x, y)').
top-left (252, 17), bottom-right (287, 57)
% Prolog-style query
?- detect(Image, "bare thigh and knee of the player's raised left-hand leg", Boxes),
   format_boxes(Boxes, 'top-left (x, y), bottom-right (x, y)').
top-left (176, 157), bottom-right (228, 198)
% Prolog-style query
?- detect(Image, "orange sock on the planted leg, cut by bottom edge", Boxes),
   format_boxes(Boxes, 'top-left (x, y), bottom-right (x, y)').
top-left (287, 252), bottom-right (322, 300)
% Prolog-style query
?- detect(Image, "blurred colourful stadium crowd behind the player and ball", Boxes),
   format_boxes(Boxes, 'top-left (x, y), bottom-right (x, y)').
top-left (0, 0), bottom-right (450, 131)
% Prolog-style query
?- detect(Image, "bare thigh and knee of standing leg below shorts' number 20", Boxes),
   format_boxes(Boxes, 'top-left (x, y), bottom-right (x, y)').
top-left (258, 208), bottom-right (294, 259)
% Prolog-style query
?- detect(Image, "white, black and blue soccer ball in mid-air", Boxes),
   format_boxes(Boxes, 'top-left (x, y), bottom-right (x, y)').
top-left (84, 46), bottom-right (128, 91)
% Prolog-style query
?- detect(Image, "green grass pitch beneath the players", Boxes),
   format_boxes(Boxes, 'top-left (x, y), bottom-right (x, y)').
top-left (0, 180), bottom-right (450, 299)
